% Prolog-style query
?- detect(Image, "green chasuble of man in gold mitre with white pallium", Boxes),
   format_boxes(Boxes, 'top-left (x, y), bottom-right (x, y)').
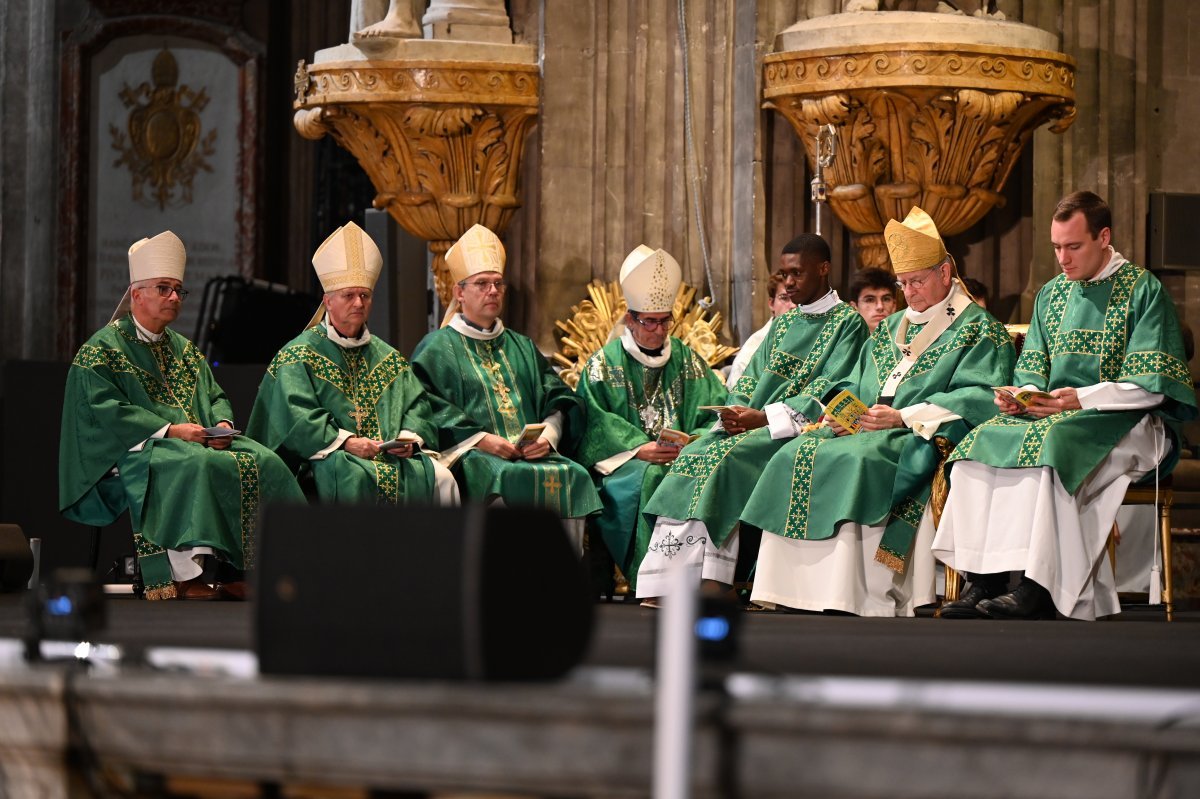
top-left (742, 302), bottom-right (1015, 572)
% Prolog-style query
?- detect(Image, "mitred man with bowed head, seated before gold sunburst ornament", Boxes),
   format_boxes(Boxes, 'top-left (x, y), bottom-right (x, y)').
top-left (575, 245), bottom-right (726, 584)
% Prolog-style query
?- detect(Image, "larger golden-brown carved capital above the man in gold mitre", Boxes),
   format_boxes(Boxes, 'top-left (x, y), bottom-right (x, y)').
top-left (763, 14), bottom-right (1075, 269)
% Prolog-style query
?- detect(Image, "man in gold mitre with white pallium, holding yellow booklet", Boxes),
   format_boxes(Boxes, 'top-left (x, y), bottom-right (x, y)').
top-left (742, 208), bottom-right (1015, 617)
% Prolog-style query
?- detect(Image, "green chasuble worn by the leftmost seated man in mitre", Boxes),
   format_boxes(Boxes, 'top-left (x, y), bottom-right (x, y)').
top-left (59, 314), bottom-right (305, 599)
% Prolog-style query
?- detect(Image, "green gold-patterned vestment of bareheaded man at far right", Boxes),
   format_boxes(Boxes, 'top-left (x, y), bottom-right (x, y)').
top-left (950, 262), bottom-right (1196, 484)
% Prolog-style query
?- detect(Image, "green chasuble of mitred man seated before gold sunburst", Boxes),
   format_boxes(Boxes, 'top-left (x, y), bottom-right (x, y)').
top-left (575, 338), bottom-right (726, 585)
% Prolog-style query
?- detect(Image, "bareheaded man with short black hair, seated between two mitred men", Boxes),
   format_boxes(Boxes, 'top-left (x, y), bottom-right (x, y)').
top-left (637, 233), bottom-right (866, 597)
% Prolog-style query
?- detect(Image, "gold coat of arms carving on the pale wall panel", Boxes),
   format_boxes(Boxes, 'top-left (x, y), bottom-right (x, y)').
top-left (109, 48), bottom-right (217, 210)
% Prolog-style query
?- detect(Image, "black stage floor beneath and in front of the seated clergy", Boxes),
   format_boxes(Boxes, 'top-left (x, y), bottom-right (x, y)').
top-left (0, 594), bottom-right (1200, 689)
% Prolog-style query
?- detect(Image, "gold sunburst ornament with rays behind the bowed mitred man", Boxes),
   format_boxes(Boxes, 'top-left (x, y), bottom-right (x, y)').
top-left (553, 281), bottom-right (738, 389)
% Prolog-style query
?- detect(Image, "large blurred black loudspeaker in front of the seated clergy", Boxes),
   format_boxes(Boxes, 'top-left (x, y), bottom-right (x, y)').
top-left (254, 505), bottom-right (594, 680)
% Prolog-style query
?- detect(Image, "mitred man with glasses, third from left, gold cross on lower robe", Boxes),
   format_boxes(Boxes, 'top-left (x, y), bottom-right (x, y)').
top-left (413, 224), bottom-right (600, 535)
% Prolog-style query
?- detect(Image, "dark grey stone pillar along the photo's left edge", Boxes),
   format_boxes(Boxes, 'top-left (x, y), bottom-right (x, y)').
top-left (0, 0), bottom-right (59, 361)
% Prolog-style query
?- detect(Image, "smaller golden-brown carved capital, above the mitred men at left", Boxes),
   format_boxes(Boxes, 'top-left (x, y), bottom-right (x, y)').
top-left (294, 61), bottom-right (539, 302)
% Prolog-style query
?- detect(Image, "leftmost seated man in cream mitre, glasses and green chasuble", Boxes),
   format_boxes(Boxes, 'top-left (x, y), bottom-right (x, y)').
top-left (59, 230), bottom-right (304, 599)
